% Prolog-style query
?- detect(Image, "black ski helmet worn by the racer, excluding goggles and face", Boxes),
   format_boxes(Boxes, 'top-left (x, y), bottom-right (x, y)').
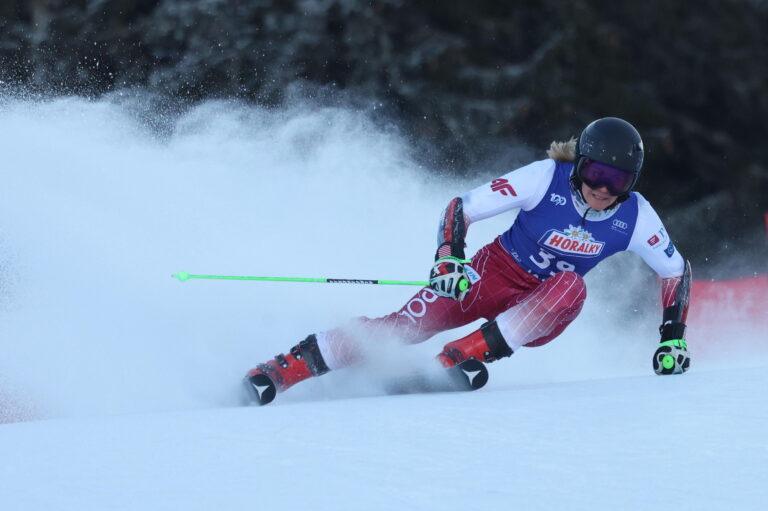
top-left (573, 117), bottom-right (643, 202)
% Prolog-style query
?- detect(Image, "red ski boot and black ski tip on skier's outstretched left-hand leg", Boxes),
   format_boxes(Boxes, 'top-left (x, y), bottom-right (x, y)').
top-left (244, 334), bottom-right (329, 405)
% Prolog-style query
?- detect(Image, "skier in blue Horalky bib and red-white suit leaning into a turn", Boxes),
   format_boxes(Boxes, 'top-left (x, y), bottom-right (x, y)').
top-left (245, 117), bottom-right (690, 404)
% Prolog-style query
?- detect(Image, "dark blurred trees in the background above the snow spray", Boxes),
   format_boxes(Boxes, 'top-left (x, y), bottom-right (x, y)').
top-left (0, 0), bottom-right (768, 271)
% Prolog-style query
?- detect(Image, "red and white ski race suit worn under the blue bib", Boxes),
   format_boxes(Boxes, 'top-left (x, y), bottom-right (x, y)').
top-left (316, 160), bottom-right (684, 369)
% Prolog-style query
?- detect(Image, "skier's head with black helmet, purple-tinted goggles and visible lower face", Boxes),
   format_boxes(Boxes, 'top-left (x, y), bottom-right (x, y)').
top-left (572, 117), bottom-right (643, 211)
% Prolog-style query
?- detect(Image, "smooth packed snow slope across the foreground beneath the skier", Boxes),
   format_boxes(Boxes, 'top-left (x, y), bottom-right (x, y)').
top-left (0, 370), bottom-right (768, 511)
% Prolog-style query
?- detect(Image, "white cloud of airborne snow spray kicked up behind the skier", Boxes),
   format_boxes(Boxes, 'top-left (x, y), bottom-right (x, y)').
top-left (0, 94), bottom-right (764, 420)
